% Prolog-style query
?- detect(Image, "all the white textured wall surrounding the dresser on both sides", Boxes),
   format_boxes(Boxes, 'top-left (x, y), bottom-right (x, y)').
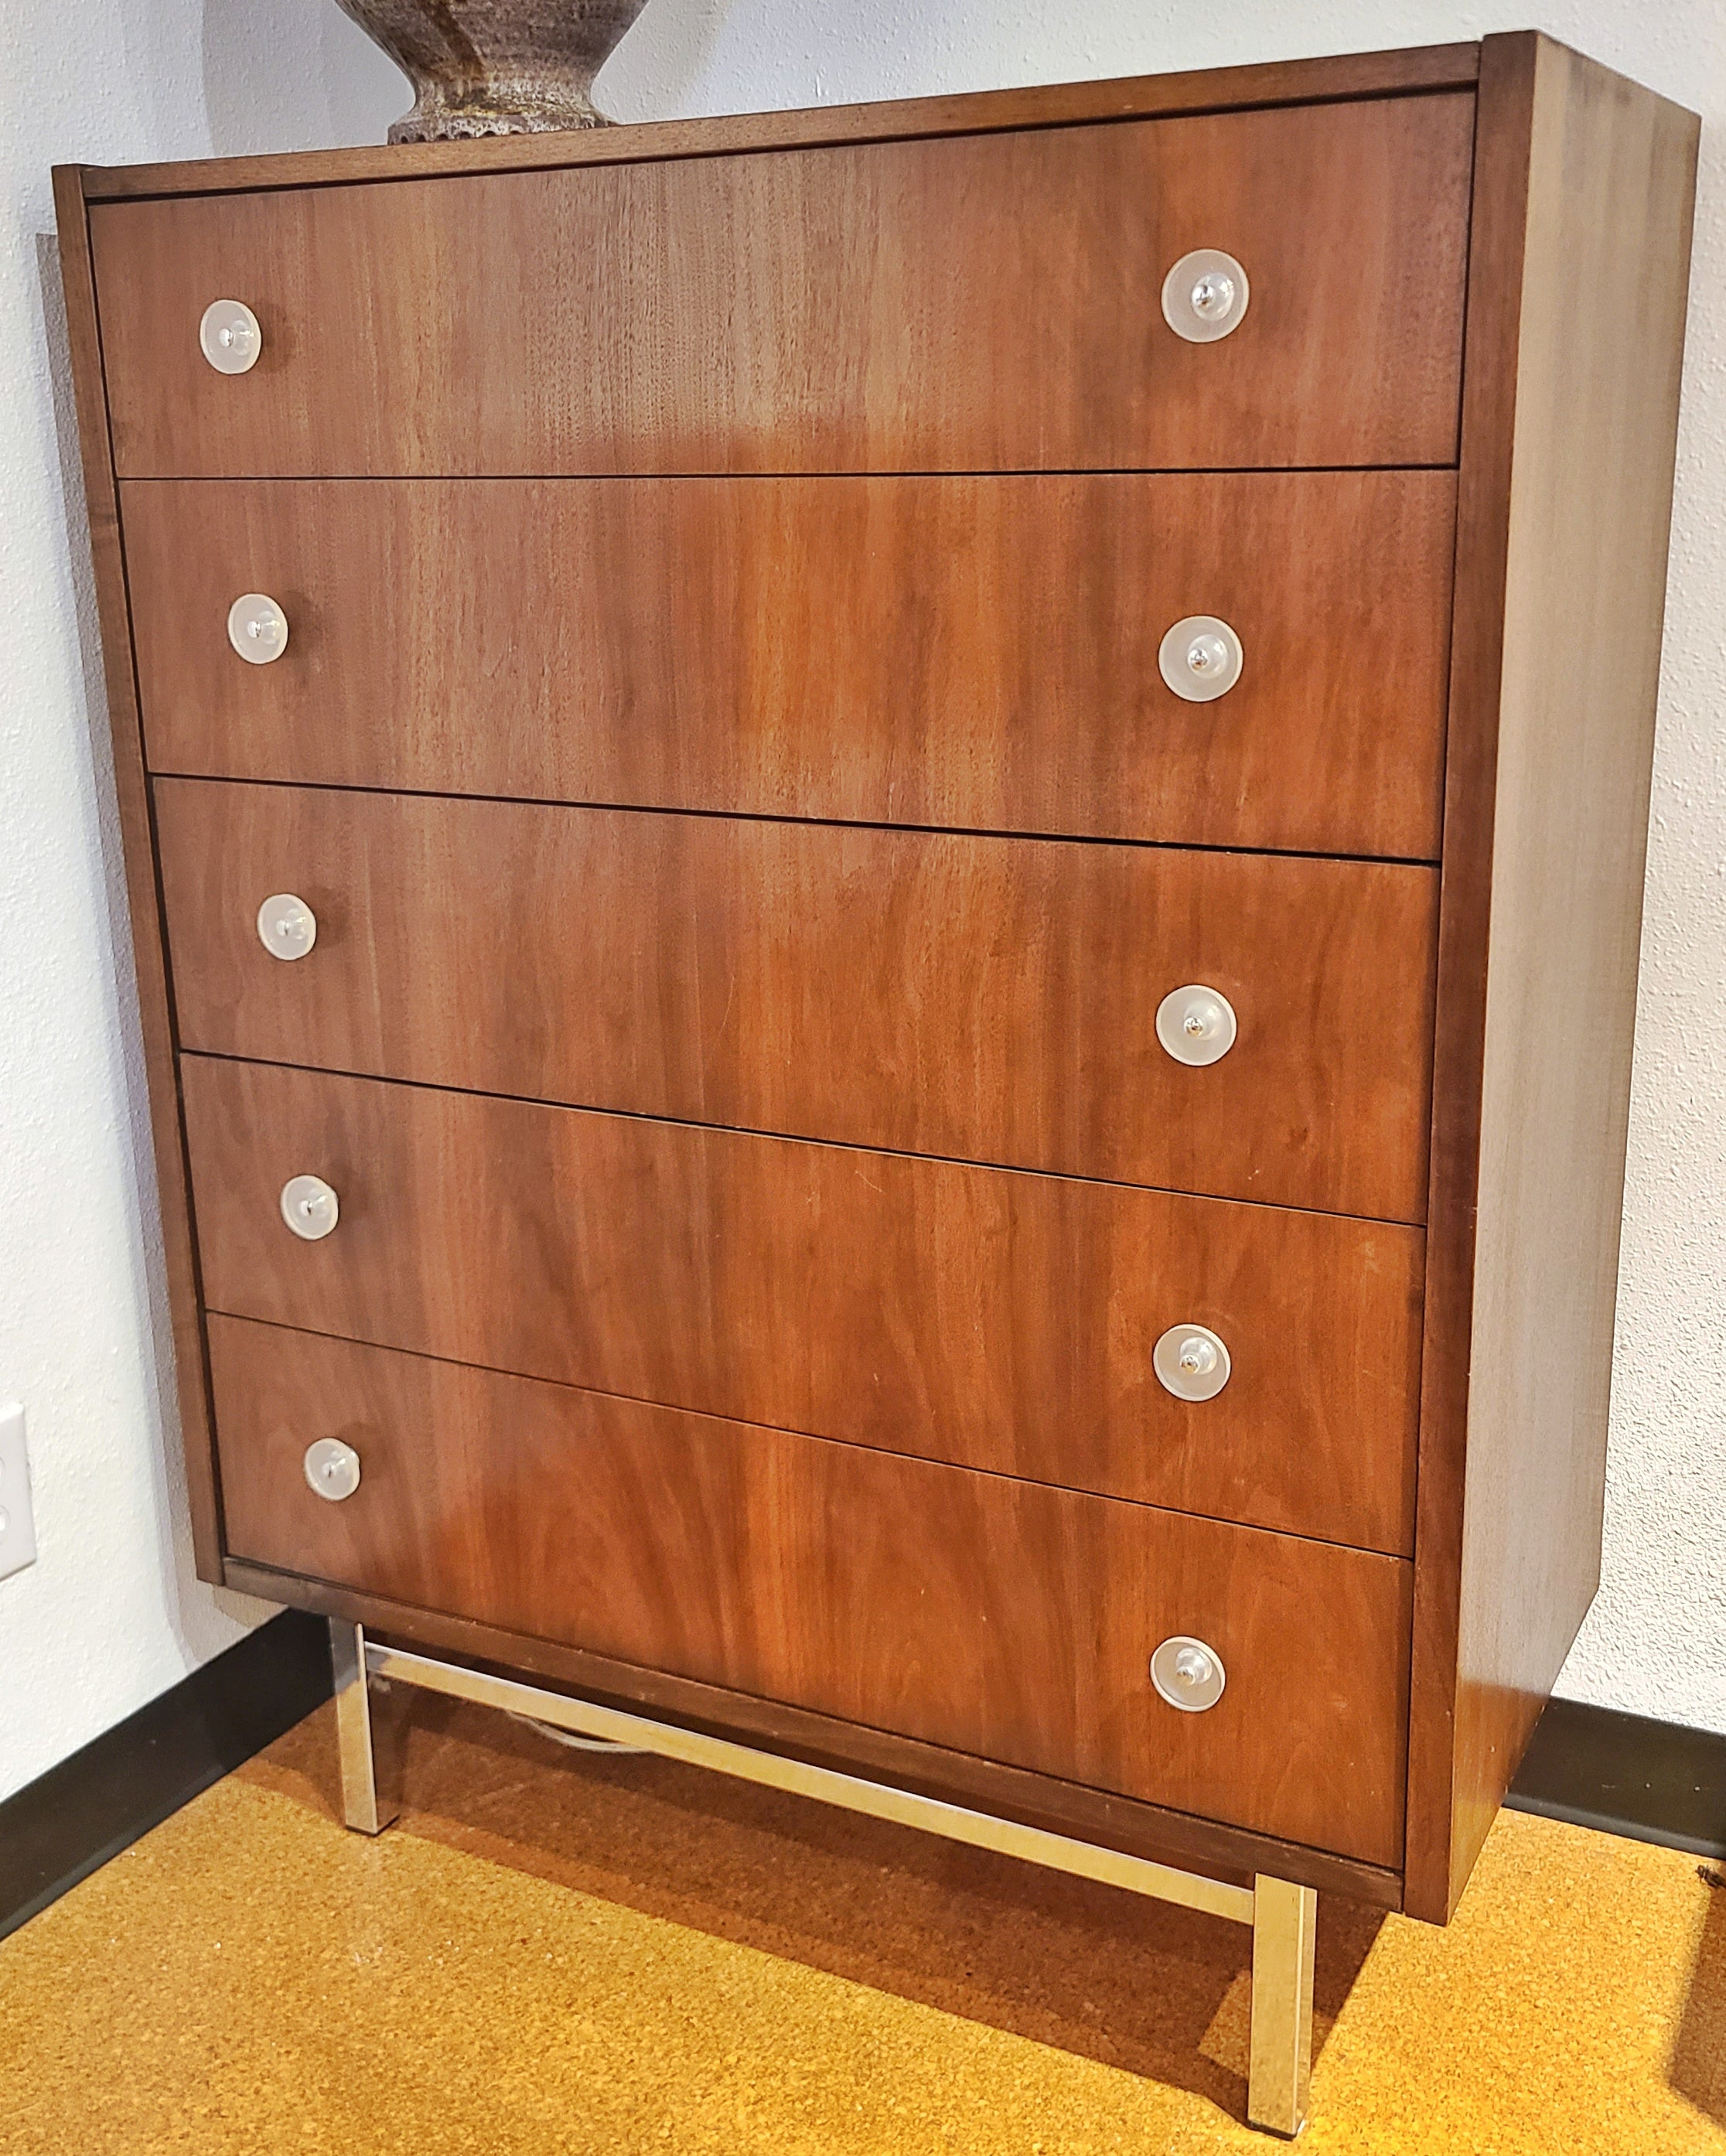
top-left (0, 0), bottom-right (1726, 1794)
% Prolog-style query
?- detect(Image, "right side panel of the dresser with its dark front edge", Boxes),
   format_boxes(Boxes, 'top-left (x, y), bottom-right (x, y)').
top-left (1407, 35), bottom-right (1696, 1921)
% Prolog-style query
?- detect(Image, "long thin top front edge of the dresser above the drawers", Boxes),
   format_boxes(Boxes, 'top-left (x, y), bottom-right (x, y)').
top-left (73, 43), bottom-right (1480, 203)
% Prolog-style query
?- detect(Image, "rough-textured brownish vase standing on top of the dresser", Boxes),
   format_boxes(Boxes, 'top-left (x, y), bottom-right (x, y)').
top-left (336, 0), bottom-right (646, 142)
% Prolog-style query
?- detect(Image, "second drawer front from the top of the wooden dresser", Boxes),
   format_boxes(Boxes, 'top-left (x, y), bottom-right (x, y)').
top-left (123, 472), bottom-right (1455, 858)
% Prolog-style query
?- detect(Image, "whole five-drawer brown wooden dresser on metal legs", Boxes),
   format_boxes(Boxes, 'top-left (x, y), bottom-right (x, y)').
top-left (58, 35), bottom-right (1696, 2130)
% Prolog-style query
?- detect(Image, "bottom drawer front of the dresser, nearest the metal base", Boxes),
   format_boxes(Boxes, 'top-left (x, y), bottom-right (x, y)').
top-left (209, 1317), bottom-right (1409, 1865)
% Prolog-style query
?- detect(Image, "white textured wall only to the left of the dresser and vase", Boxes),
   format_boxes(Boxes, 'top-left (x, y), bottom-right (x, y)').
top-left (0, 0), bottom-right (403, 1796)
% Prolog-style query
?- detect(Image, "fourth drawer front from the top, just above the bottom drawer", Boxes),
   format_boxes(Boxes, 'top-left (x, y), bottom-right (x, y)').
top-left (183, 1056), bottom-right (1422, 1552)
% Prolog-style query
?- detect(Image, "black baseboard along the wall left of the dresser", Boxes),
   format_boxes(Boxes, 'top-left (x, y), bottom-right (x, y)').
top-left (0, 1611), bottom-right (329, 1938)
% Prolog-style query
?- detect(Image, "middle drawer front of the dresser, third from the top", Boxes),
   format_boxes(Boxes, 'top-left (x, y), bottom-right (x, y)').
top-left (155, 780), bottom-right (1438, 1220)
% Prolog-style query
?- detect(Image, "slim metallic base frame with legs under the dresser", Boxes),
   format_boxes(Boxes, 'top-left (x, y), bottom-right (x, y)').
top-left (329, 1617), bottom-right (1318, 2137)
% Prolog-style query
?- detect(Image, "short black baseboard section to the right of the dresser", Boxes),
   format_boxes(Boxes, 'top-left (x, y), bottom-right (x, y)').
top-left (1504, 1699), bottom-right (1726, 1856)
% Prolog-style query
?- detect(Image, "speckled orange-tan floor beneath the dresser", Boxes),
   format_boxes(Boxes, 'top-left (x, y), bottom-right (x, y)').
top-left (0, 1694), bottom-right (1726, 2156)
